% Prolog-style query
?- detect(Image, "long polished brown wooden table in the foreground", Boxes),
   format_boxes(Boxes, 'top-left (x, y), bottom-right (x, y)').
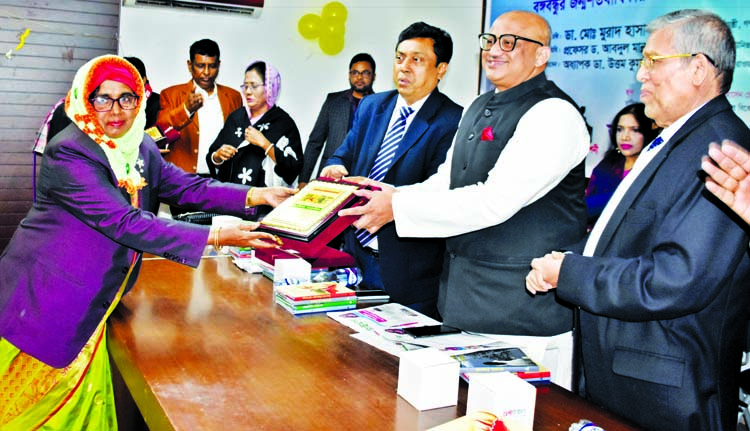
top-left (109, 257), bottom-right (648, 431)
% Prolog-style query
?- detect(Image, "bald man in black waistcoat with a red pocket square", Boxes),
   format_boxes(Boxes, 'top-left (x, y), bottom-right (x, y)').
top-left (343, 11), bottom-right (589, 387)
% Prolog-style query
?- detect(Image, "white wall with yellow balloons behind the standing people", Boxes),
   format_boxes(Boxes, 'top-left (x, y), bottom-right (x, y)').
top-left (118, 0), bottom-right (482, 143)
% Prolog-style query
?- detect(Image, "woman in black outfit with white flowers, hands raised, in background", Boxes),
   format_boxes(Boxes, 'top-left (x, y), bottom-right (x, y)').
top-left (206, 61), bottom-right (303, 208)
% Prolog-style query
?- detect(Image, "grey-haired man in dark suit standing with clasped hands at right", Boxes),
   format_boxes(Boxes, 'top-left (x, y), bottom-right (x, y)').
top-left (527, 10), bottom-right (750, 431)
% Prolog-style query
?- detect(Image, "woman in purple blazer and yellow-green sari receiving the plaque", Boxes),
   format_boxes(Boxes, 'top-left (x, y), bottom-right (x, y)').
top-left (0, 55), bottom-right (293, 430)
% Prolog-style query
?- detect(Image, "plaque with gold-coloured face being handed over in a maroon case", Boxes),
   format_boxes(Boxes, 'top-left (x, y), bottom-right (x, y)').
top-left (258, 180), bottom-right (362, 241)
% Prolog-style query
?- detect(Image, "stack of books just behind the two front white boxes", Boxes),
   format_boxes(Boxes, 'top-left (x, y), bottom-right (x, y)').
top-left (451, 347), bottom-right (551, 385)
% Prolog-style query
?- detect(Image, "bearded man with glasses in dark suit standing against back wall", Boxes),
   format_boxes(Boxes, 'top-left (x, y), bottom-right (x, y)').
top-left (299, 52), bottom-right (375, 187)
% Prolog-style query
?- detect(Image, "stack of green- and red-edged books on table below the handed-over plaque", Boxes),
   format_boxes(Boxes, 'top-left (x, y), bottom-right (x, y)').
top-left (274, 281), bottom-right (357, 315)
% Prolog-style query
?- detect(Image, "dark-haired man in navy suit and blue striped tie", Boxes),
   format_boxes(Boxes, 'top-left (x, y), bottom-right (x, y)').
top-left (321, 22), bottom-right (461, 316)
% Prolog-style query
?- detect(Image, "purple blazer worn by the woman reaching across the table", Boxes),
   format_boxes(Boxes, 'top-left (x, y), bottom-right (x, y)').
top-left (0, 126), bottom-right (253, 367)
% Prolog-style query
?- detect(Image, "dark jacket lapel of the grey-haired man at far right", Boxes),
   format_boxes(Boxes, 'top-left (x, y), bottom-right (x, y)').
top-left (594, 96), bottom-right (731, 256)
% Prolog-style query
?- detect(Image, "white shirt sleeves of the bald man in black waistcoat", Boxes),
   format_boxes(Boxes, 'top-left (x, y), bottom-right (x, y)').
top-left (393, 98), bottom-right (590, 237)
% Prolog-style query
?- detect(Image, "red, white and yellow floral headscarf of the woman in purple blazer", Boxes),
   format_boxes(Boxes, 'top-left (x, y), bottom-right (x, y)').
top-left (65, 55), bottom-right (146, 195)
